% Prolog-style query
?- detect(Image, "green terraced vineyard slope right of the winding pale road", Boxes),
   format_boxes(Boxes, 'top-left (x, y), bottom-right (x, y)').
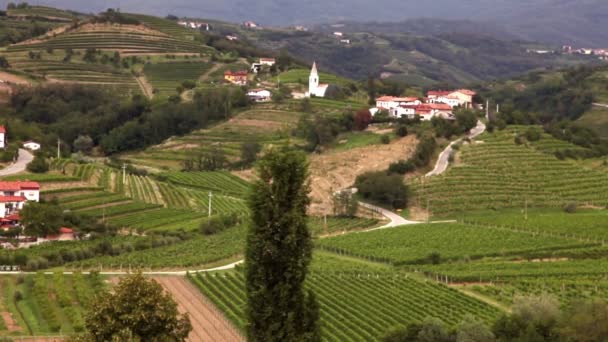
top-left (413, 127), bottom-right (608, 215)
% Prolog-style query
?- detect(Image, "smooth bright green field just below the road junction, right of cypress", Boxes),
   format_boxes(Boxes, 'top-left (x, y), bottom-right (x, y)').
top-left (317, 223), bottom-right (598, 265)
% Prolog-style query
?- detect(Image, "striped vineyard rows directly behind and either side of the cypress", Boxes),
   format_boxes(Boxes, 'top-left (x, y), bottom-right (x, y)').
top-left (190, 271), bottom-right (499, 341)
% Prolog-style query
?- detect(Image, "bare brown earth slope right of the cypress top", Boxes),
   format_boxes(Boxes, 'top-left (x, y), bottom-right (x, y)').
top-left (310, 136), bottom-right (417, 215)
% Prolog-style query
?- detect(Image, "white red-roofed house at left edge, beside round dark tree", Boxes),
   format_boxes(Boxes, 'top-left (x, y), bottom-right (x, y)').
top-left (0, 181), bottom-right (40, 218)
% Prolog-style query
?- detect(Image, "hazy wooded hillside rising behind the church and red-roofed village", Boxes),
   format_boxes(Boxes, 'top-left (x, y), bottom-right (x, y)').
top-left (224, 21), bottom-right (591, 86)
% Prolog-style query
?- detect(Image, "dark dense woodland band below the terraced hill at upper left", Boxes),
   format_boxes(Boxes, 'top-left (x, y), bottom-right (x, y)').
top-left (11, 85), bottom-right (249, 154)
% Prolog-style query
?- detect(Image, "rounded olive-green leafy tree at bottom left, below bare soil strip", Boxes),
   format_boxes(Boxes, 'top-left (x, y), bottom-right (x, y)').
top-left (82, 273), bottom-right (192, 342)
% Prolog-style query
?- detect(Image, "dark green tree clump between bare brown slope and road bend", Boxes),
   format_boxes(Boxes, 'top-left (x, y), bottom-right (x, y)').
top-left (355, 171), bottom-right (408, 209)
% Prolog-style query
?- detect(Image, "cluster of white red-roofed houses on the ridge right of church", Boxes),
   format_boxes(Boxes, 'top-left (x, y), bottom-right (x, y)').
top-left (370, 89), bottom-right (476, 121)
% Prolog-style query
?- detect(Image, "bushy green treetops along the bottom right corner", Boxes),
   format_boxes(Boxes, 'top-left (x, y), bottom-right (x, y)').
top-left (382, 294), bottom-right (608, 342)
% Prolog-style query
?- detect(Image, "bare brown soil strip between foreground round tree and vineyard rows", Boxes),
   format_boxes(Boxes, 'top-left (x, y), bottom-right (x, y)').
top-left (154, 277), bottom-right (245, 342)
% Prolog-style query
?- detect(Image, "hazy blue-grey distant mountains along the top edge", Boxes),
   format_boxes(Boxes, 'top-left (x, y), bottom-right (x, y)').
top-left (10, 0), bottom-right (608, 47)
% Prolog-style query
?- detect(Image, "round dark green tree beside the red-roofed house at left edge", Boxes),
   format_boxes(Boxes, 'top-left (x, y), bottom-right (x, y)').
top-left (19, 202), bottom-right (63, 237)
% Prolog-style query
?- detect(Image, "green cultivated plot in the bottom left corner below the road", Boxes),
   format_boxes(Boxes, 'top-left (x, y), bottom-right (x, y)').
top-left (0, 273), bottom-right (105, 336)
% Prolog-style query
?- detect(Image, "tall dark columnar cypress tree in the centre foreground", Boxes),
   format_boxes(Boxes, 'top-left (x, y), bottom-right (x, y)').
top-left (245, 149), bottom-right (320, 342)
